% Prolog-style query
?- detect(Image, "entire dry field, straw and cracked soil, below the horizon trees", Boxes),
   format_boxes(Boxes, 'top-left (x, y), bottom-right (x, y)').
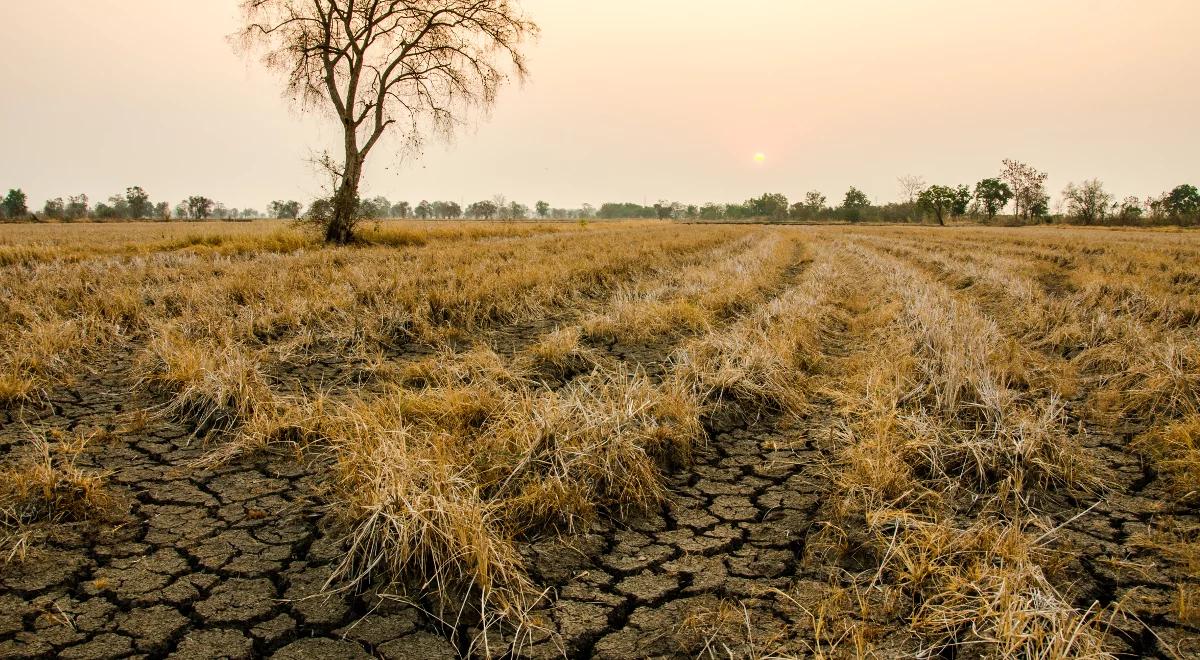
top-left (0, 222), bottom-right (1200, 659)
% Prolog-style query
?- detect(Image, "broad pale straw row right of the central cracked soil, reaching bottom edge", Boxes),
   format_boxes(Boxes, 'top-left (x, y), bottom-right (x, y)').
top-left (809, 241), bottom-right (1106, 658)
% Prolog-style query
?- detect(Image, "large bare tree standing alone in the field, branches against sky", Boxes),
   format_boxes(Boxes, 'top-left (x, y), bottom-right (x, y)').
top-left (239, 0), bottom-right (538, 244)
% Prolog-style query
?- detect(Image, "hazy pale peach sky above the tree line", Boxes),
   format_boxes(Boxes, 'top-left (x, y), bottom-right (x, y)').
top-left (0, 0), bottom-right (1200, 210)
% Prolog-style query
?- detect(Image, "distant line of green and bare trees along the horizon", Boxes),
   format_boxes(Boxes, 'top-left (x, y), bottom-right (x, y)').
top-left (0, 160), bottom-right (1200, 226)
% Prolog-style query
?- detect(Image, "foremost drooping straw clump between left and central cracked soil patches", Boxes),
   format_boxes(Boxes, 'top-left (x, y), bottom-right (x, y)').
top-left (330, 414), bottom-right (532, 633)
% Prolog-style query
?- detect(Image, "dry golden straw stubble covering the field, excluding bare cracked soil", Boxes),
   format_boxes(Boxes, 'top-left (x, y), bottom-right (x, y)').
top-left (0, 223), bottom-right (1200, 659)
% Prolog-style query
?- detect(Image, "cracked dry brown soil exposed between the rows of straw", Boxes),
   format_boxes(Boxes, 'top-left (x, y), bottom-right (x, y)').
top-left (0, 225), bottom-right (1200, 659)
